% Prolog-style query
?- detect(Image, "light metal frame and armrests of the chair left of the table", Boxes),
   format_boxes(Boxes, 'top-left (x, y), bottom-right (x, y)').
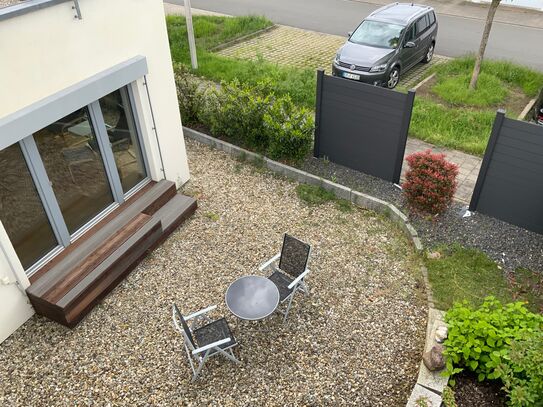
top-left (172, 304), bottom-right (241, 382)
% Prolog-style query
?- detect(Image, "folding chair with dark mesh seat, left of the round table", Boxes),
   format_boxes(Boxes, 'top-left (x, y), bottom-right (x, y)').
top-left (172, 304), bottom-right (241, 382)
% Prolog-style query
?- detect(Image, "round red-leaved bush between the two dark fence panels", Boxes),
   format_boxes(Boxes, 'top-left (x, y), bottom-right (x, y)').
top-left (402, 150), bottom-right (458, 215)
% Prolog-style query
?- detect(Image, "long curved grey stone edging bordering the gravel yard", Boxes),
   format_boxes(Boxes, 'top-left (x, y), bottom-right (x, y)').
top-left (183, 126), bottom-right (446, 405)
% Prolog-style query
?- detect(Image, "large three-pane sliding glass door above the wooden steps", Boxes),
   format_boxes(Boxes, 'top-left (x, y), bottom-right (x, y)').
top-left (0, 83), bottom-right (148, 273)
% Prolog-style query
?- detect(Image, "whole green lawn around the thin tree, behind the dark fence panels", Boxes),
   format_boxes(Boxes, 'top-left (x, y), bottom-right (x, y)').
top-left (410, 56), bottom-right (543, 156)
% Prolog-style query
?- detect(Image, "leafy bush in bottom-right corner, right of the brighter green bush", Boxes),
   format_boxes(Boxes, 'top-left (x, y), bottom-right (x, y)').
top-left (497, 331), bottom-right (543, 406)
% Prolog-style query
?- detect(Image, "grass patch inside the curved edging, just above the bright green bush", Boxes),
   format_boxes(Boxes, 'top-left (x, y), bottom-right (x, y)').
top-left (425, 245), bottom-right (543, 312)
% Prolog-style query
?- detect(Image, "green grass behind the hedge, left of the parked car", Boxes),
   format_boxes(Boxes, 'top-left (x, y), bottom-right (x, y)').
top-left (166, 16), bottom-right (316, 108)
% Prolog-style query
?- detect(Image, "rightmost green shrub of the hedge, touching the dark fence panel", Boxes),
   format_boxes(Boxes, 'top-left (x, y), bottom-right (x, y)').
top-left (263, 96), bottom-right (314, 160)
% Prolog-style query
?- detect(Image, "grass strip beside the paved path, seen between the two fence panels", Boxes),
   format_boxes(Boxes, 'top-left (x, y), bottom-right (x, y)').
top-left (409, 98), bottom-right (496, 155)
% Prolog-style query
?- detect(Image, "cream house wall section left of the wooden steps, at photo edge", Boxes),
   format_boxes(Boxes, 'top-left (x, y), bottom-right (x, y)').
top-left (0, 222), bottom-right (34, 343)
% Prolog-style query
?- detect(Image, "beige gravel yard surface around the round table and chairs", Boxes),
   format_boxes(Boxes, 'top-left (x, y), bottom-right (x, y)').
top-left (0, 140), bottom-right (427, 406)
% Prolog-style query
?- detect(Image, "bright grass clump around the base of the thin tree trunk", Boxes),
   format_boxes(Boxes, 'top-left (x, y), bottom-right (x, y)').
top-left (432, 72), bottom-right (509, 107)
